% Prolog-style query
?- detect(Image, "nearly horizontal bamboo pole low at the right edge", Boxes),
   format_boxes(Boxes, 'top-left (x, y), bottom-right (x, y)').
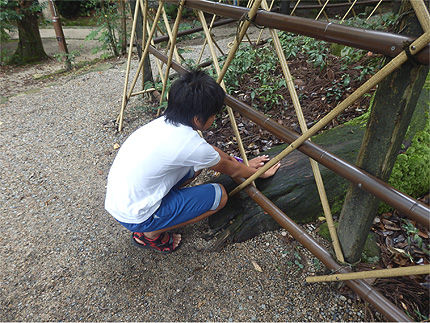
top-left (306, 265), bottom-right (430, 283)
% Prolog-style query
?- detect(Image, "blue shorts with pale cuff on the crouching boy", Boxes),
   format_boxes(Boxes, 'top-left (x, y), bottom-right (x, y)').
top-left (118, 171), bottom-right (222, 232)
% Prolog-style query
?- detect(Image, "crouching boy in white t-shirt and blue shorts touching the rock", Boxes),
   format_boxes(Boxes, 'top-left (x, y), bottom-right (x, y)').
top-left (105, 71), bottom-right (279, 253)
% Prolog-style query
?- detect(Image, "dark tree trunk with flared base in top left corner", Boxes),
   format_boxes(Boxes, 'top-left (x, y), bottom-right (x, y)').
top-left (10, 0), bottom-right (49, 64)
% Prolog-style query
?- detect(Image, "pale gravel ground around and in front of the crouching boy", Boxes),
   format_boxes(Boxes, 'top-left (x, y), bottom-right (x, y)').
top-left (0, 22), bottom-right (365, 321)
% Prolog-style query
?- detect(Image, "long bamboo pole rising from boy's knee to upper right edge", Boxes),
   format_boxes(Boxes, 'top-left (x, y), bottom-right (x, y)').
top-left (229, 32), bottom-right (430, 196)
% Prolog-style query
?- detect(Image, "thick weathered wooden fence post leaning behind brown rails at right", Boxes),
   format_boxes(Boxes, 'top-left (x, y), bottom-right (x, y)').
top-left (338, 1), bottom-right (428, 263)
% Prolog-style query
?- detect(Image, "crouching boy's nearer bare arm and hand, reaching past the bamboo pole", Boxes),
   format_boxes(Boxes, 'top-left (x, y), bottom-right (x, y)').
top-left (211, 146), bottom-right (280, 178)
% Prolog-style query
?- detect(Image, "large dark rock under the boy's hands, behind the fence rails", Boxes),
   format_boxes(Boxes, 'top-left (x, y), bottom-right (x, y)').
top-left (209, 122), bottom-right (364, 242)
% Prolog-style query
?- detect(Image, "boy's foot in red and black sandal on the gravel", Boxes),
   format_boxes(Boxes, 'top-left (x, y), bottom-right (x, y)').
top-left (131, 232), bottom-right (181, 253)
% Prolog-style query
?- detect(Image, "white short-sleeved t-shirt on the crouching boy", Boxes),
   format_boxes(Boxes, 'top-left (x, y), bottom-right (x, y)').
top-left (105, 117), bottom-right (220, 223)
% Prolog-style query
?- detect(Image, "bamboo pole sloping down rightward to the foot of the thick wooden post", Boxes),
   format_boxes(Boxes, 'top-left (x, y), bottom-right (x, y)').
top-left (261, 0), bottom-right (345, 262)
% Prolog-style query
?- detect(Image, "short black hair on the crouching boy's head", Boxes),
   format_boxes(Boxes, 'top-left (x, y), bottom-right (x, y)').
top-left (164, 70), bottom-right (225, 128)
